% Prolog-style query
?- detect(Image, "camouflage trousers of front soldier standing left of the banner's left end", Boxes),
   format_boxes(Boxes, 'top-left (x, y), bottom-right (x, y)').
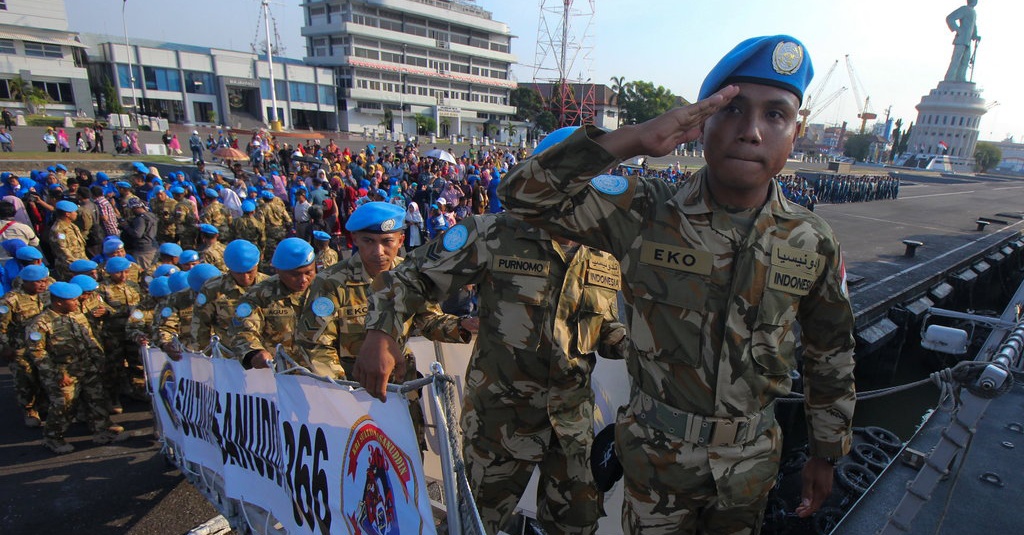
top-left (40, 366), bottom-right (113, 439)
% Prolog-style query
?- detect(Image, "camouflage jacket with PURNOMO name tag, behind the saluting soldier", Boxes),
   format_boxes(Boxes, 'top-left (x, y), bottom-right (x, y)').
top-left (367, 214), bottom-right (626, 459)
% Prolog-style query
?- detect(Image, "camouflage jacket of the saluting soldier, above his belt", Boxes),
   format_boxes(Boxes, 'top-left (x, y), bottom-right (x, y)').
top-left (499, 127), bottom-right (855, 457)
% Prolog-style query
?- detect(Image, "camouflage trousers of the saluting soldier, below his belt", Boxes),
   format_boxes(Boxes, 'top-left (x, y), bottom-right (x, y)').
top-left (615, 408), bottom-right (782, 535)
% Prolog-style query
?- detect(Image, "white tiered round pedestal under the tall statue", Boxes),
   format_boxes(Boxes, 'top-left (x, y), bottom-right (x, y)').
top-left (907, 81), bottom-right (987, 172)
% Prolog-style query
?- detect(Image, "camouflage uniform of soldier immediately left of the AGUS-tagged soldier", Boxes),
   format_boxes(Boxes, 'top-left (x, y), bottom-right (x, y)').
top-left (190, 273), bottom-right (269, 352)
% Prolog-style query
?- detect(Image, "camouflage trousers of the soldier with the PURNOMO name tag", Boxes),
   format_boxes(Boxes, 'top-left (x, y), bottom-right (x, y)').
top-left (462, 408), bottom-right (604, 534)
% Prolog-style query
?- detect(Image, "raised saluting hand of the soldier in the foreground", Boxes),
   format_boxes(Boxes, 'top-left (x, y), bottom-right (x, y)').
top-left (596, 85), bottom-right (739, 160)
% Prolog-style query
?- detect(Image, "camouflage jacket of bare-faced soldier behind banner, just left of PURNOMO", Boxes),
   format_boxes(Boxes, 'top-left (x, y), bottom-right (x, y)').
top-left (296, 254), bottom-right (471, 382)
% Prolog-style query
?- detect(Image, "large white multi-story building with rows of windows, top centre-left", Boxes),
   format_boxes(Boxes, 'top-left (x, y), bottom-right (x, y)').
top-left (302, 0), bottom-right (516, 137)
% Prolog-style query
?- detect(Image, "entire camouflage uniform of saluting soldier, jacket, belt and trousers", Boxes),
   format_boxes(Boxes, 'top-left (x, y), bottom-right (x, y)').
top-left (499, 127), bottom-right (854, 534)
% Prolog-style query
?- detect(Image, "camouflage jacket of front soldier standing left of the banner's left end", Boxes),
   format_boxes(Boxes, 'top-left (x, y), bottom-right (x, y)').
top-left (25, 307), bottom-right (103, 377)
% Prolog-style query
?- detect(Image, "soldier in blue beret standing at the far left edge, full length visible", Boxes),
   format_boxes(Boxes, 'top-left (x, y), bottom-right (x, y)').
top-left (0, 264), bottom-right (50, 427)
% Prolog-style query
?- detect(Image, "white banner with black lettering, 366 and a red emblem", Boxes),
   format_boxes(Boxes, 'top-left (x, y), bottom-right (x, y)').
top-left (146, 348), bottom-right (435, 535)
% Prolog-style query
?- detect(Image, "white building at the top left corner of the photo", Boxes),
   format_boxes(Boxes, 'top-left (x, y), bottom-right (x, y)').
top-left (0, 0), bottom-right (92, 115)
